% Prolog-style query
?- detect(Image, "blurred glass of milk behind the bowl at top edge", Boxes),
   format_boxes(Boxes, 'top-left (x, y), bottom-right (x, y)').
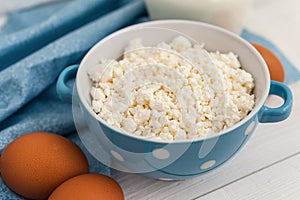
top-left (146, 0), bottom-right (252, 34)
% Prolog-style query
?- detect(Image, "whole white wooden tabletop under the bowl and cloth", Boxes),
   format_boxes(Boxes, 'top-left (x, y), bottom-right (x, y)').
top-left (113, 0), bottom-right (300, 200)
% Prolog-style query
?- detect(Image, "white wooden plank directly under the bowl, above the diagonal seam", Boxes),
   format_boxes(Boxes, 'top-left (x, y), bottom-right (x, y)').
top-left (113, 82), bottom-right (300, 200)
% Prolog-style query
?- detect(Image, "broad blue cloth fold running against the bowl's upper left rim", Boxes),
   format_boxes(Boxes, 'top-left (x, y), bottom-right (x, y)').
top-left (0, 1), bottom-right (145, 121)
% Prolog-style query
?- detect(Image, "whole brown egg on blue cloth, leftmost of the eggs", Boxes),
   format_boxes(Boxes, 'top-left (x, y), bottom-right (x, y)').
top-left (0, 132), bottom-right (89, 199)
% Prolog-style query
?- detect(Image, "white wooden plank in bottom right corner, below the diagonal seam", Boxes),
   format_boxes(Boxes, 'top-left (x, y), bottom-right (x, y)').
top-left (197, 154), bottom-right (300, 200)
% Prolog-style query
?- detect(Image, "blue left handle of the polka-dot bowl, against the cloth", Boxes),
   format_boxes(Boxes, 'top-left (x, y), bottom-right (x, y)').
top-left (56, 64), bottom-right (79, 102)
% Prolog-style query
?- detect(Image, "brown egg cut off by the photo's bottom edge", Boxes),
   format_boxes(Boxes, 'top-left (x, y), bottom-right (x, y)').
top-left (48, 174), bottom-right (124, 200)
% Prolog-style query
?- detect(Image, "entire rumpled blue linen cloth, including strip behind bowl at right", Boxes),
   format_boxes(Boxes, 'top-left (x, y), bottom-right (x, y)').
top-left (0, 0), bottom-right (300, 200)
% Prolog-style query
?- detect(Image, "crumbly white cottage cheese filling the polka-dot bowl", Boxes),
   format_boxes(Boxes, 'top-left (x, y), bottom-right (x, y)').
top-left (88, 36), bottom-right (254, 141)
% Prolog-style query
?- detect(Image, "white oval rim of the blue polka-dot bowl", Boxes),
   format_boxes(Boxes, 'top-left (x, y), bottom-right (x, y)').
top-left (76, 19), bottom-right (271, 144)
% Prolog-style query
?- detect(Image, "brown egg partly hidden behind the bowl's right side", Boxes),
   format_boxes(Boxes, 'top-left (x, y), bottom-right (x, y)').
top-left (251, 43), bottom-right (284, 82)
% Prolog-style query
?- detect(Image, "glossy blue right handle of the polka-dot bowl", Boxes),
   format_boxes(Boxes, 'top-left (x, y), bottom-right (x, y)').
top-left (259, 81), bottom-right (293, 123)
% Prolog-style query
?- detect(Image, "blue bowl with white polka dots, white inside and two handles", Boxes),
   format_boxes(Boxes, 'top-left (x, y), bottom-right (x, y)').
top-left (57, 20), bottom-right (292, 180)
